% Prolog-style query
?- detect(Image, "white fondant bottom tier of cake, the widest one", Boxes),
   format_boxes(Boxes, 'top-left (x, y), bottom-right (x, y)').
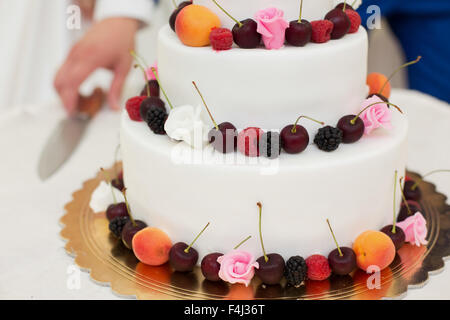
top-left (121, 112), bottom-right (408, 258)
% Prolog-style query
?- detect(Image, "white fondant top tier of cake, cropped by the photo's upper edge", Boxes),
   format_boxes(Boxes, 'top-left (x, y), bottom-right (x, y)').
top-left (194, 0), bottom-right (341, 29)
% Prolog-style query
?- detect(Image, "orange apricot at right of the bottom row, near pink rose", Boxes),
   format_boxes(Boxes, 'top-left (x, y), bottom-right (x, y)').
top-left (353, 231), bottom-right (395, 271)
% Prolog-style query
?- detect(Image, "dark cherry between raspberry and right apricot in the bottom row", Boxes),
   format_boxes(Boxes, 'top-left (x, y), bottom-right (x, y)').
top-left (327, 219), bottom-right (356, 276)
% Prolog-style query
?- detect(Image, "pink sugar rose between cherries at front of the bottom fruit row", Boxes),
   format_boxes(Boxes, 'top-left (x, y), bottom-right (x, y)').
top-left (217, 250), bottom-right (259, 287)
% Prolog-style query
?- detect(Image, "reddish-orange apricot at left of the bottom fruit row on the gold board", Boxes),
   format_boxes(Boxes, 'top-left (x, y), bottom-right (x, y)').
top-left (133, 227), bottom-right (172, 266)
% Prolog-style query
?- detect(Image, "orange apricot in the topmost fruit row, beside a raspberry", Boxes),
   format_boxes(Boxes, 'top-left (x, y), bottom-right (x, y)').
top-left (175, 4), bottom-right (221, 47)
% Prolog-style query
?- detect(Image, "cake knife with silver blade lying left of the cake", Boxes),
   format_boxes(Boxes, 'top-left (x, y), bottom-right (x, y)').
top-left (38, 88), bottom-right (104, 181)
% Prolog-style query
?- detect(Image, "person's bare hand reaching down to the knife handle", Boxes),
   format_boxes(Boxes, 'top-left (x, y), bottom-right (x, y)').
top-left (54, 18), bottom-right (139, 114)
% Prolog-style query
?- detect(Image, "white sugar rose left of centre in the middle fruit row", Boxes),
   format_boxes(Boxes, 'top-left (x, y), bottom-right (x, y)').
top-left (164, 105), bottom-right (211, 149)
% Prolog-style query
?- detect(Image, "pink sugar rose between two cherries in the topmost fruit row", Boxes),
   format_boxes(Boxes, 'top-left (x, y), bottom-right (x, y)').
top-left (255, 8), bottom-right (289, 49)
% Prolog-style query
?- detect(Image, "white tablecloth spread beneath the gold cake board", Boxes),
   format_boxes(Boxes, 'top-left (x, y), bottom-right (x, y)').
top-left (0, 90), bottom-right (450, 299)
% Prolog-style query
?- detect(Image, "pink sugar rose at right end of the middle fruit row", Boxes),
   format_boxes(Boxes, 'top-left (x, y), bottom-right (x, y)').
top-left (360, 96), bottom-right (392, 135)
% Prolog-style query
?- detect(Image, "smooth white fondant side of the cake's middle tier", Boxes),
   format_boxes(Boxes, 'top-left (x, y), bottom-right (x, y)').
top-left (158, 26), bottom-right (368, 129)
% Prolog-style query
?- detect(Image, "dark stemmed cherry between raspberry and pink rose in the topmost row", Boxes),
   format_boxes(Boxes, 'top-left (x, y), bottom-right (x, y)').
top-left (212, 0), bottom-right (262, 49)
